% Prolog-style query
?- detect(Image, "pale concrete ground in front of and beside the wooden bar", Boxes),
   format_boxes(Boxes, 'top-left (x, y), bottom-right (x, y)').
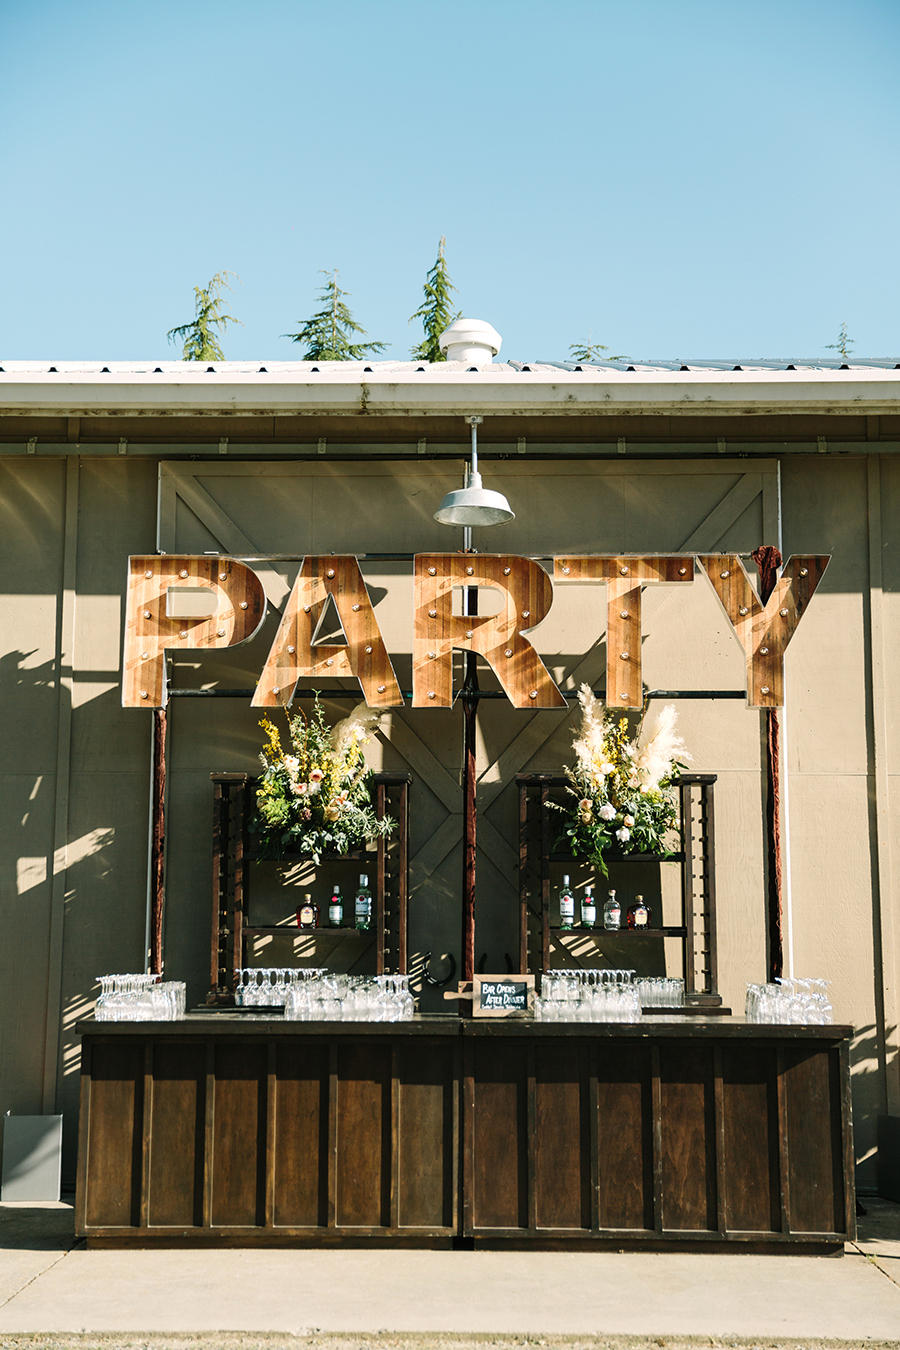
top-left (0, 1199), bottom-right (900, 1350)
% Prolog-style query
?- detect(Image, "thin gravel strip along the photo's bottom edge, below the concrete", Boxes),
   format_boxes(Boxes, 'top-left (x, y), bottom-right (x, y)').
top-left (0, 1332), bottom-right (900, 1350)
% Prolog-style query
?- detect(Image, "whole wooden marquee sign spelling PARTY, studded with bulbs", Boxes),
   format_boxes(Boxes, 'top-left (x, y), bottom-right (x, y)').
top-left (121, 554), bottom-right (830, 709)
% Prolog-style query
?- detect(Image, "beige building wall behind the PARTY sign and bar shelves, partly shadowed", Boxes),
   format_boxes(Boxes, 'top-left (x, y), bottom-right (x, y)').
top-left (0, 446), bottom-right (900, 1185)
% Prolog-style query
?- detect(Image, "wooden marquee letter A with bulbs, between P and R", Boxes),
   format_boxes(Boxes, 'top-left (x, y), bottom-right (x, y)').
top-left (252, 555), bottom-right (403, 707)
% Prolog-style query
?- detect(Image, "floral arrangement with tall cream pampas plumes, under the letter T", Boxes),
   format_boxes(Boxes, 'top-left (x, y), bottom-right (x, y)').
top-left (548, 684), bottom-right (691, 876)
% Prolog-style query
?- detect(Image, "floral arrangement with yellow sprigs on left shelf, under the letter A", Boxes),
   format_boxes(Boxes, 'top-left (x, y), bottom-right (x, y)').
top-left (250, 697), bottom-right (394, 863)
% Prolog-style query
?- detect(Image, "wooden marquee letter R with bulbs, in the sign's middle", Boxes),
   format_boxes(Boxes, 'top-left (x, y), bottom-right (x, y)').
top-left (413, 554), bottom-right (565, 707)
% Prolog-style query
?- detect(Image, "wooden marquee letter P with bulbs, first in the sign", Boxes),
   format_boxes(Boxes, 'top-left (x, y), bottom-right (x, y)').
top-left (121, 554), bottom-right (266, 707)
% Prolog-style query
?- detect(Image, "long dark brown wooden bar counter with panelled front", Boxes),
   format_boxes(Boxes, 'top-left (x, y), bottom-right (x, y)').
top-left (77, 1013), bottom-right (854, 1251)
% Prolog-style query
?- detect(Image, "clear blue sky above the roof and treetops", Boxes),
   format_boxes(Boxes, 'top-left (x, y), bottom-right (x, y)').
top-left (0, 0), bottom-right (900, 360)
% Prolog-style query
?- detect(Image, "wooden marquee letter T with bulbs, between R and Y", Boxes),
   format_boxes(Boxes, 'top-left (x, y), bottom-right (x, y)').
top-left (553, 554), bottom-right (694, 707)
